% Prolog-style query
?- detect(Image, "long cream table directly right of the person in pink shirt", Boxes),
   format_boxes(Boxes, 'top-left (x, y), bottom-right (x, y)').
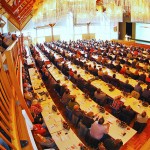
top-left (48, 64), bottom-right (136, 144)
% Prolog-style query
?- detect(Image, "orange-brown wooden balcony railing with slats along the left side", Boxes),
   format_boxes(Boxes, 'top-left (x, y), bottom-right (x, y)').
top-left (0, 37), bottom-right (33, 150)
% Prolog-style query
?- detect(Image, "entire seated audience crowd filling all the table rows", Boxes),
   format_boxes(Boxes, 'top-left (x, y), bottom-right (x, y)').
top-left (0, 39), bottom-right (150, 150)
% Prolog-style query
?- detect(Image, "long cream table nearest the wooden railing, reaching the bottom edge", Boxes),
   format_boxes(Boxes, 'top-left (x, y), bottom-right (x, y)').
top-left (29, 68), bottom-right (84, 150)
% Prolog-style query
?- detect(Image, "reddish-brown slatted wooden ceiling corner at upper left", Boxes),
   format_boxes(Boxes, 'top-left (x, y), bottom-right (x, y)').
top-left (0, 0), bottom-right (101, 30)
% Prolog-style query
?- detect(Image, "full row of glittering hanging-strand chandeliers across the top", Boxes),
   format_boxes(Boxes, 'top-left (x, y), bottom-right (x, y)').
top-left (33, 0), bottom-right (150, 26)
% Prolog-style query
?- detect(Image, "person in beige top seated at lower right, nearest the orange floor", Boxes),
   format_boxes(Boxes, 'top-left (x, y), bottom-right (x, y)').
top-left (133, 111), bottom-right (148, 133)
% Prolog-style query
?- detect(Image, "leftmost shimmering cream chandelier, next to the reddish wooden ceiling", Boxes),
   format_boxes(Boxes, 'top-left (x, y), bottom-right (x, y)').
top-left (33, 0), bottom-right (68, 26)
